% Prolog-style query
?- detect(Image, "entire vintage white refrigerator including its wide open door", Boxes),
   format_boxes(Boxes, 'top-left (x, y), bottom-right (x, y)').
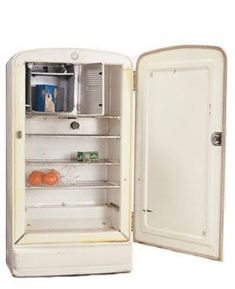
top-left (6, 46), bottom-right (226, 276)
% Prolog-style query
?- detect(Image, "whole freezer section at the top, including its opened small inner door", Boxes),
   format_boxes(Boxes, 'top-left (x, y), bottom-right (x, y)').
top-left (26, 63), bottom-right (123, 118)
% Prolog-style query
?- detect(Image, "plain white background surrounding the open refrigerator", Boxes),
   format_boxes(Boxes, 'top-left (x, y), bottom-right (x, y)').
top-left (0, 0), bottom-right (235, 289)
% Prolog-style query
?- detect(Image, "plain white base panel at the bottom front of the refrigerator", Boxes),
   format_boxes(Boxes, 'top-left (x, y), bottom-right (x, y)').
top-left (7, 243), bottom-right (132, 277)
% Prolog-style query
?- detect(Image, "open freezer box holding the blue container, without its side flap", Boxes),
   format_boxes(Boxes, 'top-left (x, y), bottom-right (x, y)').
top-left (26, 63), bottom-right (75, 114)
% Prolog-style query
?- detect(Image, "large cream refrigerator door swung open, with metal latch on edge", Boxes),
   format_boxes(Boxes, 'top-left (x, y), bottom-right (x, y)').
top-left (134, 46), bottom-right (226, 260)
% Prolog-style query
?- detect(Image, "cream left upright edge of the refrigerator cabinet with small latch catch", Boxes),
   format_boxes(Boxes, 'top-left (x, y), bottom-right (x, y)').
top-left (7, 62), bottom-right (25, 241)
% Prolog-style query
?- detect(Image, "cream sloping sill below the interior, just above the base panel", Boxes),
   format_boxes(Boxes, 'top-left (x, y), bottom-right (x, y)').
top-left (17, 227), bottom-right (129, 245)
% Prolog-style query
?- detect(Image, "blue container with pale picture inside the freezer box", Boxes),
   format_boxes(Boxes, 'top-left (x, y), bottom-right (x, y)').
top-left (32, 84), bottom-right (58, 112)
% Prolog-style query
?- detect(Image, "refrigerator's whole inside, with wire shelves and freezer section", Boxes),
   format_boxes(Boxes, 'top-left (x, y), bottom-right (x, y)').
top-left (25, 63), bottom-right (125, 242)
